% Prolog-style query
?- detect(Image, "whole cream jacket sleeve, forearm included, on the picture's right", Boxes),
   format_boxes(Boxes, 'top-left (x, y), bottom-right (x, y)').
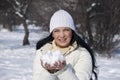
top-left (55, 50), bottom-right (92, 80)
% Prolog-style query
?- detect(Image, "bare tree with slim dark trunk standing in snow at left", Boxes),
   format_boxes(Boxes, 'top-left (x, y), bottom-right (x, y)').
top-left (7, 0), bottom-right (31, 45)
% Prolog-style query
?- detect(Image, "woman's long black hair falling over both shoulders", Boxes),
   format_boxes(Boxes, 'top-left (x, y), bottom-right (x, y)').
top-left (36, 30), bottom-right (98, 80)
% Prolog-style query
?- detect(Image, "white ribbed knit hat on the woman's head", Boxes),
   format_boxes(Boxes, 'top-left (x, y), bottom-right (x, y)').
top-left (50, 10), bottom-right (75, 33)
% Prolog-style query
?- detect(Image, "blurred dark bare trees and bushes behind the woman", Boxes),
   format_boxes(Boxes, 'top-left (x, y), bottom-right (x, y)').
top-left (0, 0), bottom-right (120, 56)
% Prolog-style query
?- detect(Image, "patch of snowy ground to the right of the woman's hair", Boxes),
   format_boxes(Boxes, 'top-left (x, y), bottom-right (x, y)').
top-left (97, 57), bottom-right (120, 80)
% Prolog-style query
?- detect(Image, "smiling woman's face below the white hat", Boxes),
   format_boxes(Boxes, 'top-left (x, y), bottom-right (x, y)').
top-left (52, 27), bottom-right (72, 48)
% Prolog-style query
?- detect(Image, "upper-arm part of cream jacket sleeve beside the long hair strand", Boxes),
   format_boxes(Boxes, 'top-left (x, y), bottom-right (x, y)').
top-left (74, 48), bottom-right (92, 80)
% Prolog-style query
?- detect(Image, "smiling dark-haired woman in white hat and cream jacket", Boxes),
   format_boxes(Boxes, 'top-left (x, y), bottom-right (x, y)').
top-left (33, 10), bottom-right (97, 80)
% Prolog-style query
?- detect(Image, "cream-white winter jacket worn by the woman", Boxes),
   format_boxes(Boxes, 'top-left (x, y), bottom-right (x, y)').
top-left (33, 43), bottom-right (92, 80)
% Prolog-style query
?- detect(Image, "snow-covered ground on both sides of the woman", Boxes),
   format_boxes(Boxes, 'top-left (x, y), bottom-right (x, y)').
top-left (0, 27), bottom-right (120, 80)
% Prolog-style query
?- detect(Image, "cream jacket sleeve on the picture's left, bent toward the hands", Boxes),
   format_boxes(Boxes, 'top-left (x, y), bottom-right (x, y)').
top-left (33, 50), bottom-right (56, 80)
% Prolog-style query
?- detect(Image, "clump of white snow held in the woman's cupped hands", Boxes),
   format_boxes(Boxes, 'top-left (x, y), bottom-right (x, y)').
top-left (41, 50), bottom-right (65, 66)
